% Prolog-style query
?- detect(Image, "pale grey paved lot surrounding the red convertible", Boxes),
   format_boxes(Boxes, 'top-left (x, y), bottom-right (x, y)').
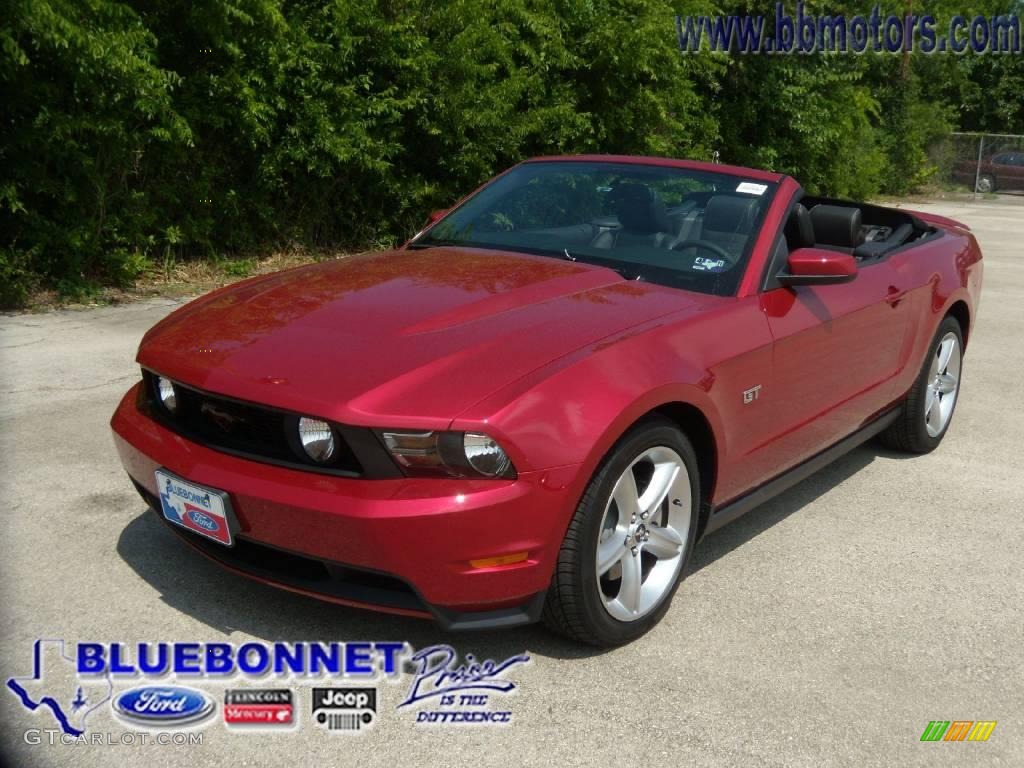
top-left (0, 198), bottom-right (1024, 768)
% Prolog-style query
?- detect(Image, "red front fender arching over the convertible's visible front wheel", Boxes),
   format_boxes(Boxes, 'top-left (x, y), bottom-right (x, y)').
top-left (452, 297), bottom-right (772, 501)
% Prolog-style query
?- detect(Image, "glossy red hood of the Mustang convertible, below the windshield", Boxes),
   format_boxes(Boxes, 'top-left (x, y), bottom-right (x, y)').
top-left (138, 248), bottom-right (702, 428)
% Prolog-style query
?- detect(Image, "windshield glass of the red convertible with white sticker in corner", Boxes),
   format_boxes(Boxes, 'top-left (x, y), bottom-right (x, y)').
top-left (410, 161), bottom-right (776, 296)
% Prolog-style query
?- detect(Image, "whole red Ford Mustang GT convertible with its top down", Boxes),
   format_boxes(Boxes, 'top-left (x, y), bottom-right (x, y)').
top-left (113, 156), bottom-right (982, 646)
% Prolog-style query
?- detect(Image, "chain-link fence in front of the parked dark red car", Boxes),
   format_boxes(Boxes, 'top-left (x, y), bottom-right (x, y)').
top-left (929, 133), bottom-right (1024, 200)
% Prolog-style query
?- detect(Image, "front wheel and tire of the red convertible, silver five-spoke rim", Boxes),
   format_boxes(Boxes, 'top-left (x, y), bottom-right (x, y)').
top-left (543, 417), bottom-right (700, 647)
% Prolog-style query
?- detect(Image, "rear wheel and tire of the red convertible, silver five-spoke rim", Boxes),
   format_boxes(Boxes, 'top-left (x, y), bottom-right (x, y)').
top-left (880, 316), bottom-right (964, 454)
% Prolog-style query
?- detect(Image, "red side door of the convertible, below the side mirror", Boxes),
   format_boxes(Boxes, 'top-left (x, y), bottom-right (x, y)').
top-left (761, 249), bottom-right (909, 469)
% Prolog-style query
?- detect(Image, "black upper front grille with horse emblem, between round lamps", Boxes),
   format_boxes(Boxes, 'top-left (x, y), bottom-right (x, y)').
top-left (143, 371), bottom-right (368, 477)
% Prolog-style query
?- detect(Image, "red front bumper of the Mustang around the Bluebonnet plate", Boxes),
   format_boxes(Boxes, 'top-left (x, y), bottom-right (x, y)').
top-left (111, 385), bottom-right (579, 629)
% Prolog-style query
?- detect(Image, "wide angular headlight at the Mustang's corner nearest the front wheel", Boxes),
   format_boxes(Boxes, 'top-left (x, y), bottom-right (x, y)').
top-left (380, 430), bottom-right (516, 479)
